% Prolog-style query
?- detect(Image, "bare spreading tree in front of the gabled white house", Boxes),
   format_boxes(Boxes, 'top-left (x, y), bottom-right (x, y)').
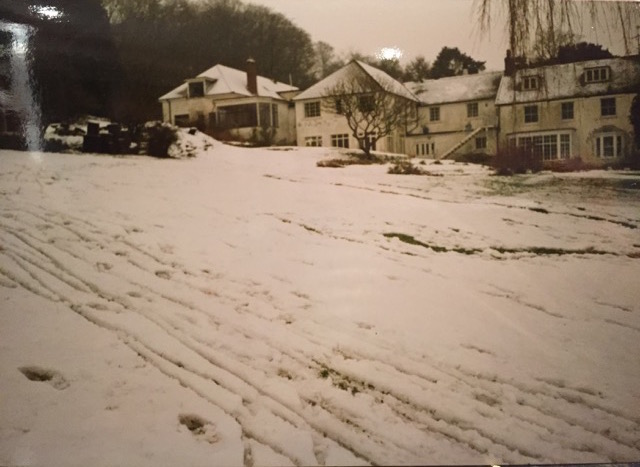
top-left (323, 68), bottom-right (417, 158)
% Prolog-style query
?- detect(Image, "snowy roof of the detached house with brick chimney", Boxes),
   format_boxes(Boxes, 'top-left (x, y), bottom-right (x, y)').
top-left (160, 65), bottom-right (298, 100)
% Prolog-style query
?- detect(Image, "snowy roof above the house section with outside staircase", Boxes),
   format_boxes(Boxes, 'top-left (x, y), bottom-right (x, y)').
top-left (405, 72), bottom-right (502, 105)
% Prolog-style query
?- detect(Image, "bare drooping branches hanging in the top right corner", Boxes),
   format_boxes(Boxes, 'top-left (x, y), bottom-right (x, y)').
top-left (475, 0), bottom-right (640, 58)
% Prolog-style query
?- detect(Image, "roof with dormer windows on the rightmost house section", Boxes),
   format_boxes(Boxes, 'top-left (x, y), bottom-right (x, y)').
top-left (496, 55), bottom-right (640, 105)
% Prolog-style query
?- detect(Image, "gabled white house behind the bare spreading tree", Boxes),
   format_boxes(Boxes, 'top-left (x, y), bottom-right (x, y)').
top-left (294, 60), bottom-right (417, 153)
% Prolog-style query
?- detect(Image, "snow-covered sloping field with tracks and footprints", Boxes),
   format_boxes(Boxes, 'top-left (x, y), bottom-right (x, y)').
top-left (0, 144), bottom-right (640, 466)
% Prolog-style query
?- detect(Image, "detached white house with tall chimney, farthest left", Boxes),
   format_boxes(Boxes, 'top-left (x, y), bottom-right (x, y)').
top-left (159, 59), bottom-right (298, 144)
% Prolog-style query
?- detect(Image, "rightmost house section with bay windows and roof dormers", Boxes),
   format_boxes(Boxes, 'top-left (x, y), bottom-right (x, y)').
top-left (496, 56), bottom-right (640, 165)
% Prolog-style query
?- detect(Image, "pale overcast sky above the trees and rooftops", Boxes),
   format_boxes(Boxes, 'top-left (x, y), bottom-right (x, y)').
top-left (248, 0), bottom-right (635, 70)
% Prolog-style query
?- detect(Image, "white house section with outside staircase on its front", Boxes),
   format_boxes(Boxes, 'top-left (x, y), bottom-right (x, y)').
top-left (405, 72), bottom-right (502, 159)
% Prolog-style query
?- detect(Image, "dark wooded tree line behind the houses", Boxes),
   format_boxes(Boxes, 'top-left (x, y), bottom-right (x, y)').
top-left (0, 0), bottom-right (632, 130)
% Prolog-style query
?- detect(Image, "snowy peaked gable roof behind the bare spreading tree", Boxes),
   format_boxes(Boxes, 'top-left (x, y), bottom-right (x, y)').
top-left (294, 60), bottom-right (418, 101)
